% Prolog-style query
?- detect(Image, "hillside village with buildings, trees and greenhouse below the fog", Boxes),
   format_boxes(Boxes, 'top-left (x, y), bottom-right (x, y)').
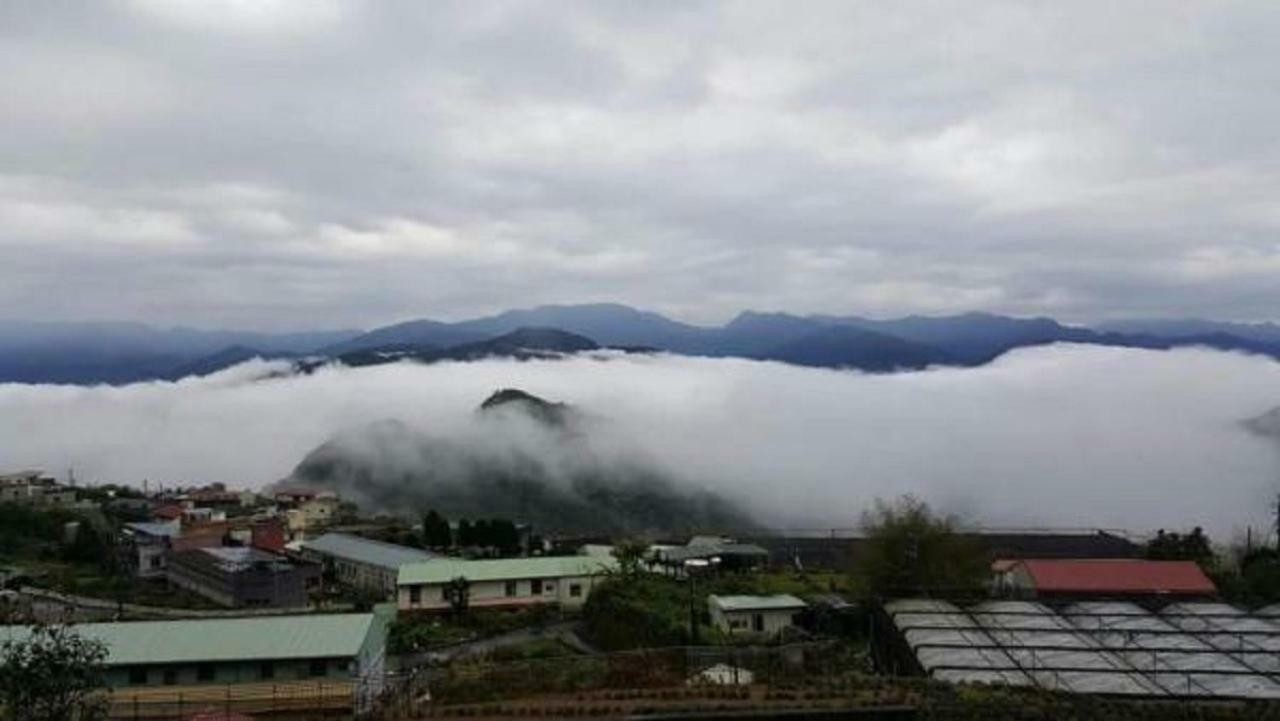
top-left (0, 471), bottom-right (1280, 720)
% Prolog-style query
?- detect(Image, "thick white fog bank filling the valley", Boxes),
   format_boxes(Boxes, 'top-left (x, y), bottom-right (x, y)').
top-left (0, 346), bottom-right (1280, 534)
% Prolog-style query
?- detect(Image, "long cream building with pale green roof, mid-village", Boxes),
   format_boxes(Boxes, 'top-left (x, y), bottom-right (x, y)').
top-left (396, 556), bottom-right (617, 611)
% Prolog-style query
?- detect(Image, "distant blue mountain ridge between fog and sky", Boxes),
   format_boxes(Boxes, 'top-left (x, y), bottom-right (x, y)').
top-left (0, 304), bottom-right (1280, 384)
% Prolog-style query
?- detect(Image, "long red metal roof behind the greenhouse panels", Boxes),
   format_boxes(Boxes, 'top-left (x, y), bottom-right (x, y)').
top-left (1019, 558), bottom-right (1217, 594)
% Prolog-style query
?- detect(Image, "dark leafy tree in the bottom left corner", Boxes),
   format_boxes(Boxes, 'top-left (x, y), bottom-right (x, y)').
top-left (0, 626), bottom-right (106, 721)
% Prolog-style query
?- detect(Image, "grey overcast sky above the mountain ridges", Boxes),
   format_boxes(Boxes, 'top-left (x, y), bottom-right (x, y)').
top-left (0, 0), bottom-right (1280, 329)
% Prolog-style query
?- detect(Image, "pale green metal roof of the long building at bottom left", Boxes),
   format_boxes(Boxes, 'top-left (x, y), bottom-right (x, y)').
top-left (0, 613), bottom-right (375, 666)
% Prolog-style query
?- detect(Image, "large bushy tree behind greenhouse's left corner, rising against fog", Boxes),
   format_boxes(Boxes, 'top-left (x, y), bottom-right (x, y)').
top-left (858, 496), bottom-right (989, 597)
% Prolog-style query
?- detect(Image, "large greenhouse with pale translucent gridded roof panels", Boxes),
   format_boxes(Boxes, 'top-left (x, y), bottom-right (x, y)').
top-left (877, 599), bottom-right (1280, 698)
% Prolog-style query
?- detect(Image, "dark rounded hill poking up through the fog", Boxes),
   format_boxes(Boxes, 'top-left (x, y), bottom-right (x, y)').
top-left (284, 389), bottom-right (755, 534)
